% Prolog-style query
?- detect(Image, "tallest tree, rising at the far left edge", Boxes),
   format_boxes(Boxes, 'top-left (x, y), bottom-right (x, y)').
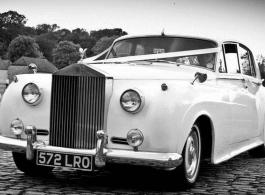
top-left (0, 11), bottom-right (27, 56)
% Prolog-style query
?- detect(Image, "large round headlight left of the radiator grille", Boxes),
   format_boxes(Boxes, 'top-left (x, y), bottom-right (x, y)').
top-left (22, 83), bottom-right (42, 105)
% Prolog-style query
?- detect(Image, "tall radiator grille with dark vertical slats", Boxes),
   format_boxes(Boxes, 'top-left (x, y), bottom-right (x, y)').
top-left (49, 75), bottom-right (105, 149)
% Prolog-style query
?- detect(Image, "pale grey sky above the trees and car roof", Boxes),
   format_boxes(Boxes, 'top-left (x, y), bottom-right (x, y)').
top-left (0, 0), bottom-right (265, 56)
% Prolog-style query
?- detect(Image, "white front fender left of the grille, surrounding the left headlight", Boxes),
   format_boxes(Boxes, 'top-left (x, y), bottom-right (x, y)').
top-left (0, 74), bottom-right (52, 139)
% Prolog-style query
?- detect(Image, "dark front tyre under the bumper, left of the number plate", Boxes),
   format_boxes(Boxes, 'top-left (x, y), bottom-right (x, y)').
top-left (12, 152), bottom-right (53, 175)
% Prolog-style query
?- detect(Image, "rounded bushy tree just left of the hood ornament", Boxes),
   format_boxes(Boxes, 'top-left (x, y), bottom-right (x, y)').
top-left (52, 41), bottom-right (80, 69)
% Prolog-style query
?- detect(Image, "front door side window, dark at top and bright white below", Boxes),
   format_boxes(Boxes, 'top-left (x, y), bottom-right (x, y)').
top-left (223, 44), bottom-right (240, 74)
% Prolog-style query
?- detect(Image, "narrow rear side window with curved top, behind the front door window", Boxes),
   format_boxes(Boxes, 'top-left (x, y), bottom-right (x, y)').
top-left (238, 45), bottom-right (256, 77)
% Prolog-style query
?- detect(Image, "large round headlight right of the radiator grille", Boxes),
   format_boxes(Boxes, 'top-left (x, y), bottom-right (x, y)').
top-left (120, 89), bottom-right (144, 114)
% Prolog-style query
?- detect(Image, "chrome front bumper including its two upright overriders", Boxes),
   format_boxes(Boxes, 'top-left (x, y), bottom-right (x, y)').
top-left (0, 130), bottom-right (182, 169)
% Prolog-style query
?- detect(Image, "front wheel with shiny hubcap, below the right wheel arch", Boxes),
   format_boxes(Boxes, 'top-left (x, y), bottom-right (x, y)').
top-left (179, 123), bottom-right (201, 187)
